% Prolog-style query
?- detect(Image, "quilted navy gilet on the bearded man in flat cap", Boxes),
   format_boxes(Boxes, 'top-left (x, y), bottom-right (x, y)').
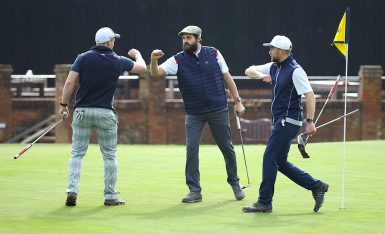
top-left (174, 46), bottom-right (227, 115)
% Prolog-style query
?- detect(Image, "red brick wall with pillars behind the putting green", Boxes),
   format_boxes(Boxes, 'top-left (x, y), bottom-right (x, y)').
top-left (0, 65), bottom-right (385, 144)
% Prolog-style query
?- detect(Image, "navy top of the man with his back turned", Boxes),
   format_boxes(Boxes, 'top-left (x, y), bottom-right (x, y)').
top-left (75, 46), bottom-right (121, 109)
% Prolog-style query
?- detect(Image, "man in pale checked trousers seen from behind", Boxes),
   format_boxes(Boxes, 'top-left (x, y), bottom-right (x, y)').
top-left (59, 27), bottom-right (146, 206)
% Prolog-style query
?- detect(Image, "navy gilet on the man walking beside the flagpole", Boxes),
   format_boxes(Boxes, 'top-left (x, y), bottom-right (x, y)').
top-left (270, 56), bottom-right (303, 123)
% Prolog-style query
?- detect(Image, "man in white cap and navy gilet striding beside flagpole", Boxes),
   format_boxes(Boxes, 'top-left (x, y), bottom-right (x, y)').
top-left (243, 35), bottom-right (329, 212)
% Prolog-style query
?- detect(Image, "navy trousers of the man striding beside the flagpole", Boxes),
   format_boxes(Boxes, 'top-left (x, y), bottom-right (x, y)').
top-left (258, 119), bottom-right (322, 205)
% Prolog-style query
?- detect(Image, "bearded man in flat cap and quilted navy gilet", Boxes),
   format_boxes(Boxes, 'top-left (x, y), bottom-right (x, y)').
top-left (150, 26), bottom-right (245, 203)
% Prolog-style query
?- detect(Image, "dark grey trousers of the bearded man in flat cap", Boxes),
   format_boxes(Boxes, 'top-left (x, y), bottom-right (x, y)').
top-left (185, 108), bottom-right (239, 192)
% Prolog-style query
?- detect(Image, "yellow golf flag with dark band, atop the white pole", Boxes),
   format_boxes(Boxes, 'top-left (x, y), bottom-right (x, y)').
top-left (332, 7), bottom-right (350, 59)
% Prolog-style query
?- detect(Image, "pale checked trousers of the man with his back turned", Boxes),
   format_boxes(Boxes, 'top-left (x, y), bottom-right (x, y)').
top-left (66, 108), bottom-right (118, 199)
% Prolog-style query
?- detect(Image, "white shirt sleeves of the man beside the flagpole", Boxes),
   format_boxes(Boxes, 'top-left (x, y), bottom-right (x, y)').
top-left (256, 62), bottom-right (313, 95)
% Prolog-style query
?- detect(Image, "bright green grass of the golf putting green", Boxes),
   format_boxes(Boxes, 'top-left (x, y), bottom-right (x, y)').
top-left (0, 141), bottom-right (385, 234)
